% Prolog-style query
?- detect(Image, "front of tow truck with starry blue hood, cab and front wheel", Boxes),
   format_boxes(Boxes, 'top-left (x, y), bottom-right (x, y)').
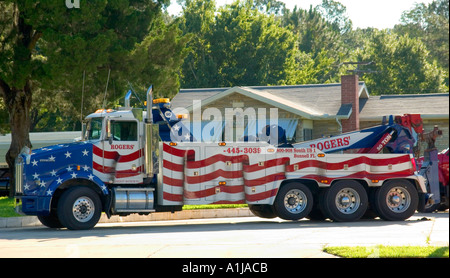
top-left (15, 87), bottom-right (169, 229)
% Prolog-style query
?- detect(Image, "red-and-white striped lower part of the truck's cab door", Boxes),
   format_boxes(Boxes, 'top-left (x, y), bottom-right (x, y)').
top-left (92, 142), bottom-right (144, 184)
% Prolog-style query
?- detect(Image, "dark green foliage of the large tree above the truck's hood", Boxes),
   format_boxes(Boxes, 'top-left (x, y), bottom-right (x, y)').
top-left (0, 0), bottom-right (190, 134)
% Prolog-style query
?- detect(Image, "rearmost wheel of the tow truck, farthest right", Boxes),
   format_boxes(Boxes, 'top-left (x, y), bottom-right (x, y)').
top-left (374, 180), bottom-right (419, 221)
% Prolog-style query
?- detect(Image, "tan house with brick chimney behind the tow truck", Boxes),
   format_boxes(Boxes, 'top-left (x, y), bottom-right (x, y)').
top-left (172, 75), bottom-right (449, 149)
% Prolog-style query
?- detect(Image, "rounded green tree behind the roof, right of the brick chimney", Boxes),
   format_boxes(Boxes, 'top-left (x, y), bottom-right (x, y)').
top-left (357, 30), bottom-right (448, 95)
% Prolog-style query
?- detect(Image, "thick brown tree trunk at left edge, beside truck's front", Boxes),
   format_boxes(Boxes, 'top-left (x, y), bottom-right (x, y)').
top-left (0, 80), bottom-right (32, 197)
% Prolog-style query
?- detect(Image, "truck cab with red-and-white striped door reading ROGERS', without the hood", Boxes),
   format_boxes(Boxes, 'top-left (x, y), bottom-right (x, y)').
top-left (82, 109), bottom-right (146, 184)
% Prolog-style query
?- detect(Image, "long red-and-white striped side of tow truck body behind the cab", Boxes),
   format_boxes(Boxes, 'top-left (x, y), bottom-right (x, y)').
top-left (160, 143), bottom-right (416, 205)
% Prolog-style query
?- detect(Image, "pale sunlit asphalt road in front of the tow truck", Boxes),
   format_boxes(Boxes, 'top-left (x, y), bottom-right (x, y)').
top-left (0, 211), bottom-right (449, 258)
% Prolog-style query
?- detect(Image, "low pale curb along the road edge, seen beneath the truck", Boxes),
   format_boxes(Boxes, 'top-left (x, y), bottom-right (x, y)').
top-left (0, 208), bottom-right (254, 229)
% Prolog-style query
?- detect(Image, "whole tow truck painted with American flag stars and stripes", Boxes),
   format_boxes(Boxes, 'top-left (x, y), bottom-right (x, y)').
top-left (15, 86), bottom-right (429, 230)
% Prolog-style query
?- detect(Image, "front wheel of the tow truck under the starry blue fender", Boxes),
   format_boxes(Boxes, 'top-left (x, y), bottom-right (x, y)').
top-left (58, 186), bottom-right (102, 230)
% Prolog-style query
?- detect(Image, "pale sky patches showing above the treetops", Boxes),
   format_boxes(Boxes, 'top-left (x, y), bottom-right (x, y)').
top-left (168, 0), bottom-right (432, 29)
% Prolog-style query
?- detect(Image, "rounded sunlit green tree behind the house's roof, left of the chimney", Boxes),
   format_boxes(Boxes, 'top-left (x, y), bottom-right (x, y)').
top-left (208, 1), bottom-right (296, 87)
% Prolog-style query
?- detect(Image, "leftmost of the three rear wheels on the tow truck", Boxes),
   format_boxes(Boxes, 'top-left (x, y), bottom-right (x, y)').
top-left (273, 182), bottom-right (313, 220)
